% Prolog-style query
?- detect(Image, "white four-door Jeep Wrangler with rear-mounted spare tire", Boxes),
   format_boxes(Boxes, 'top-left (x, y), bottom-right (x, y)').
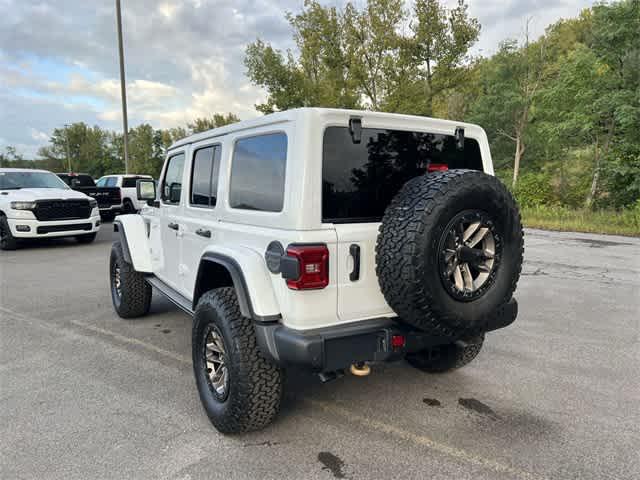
top-left (110, 108), bottom-right (523, 433)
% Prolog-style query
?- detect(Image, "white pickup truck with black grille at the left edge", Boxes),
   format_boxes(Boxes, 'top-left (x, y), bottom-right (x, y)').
top-left (0, 168), bottom-right (100, 250)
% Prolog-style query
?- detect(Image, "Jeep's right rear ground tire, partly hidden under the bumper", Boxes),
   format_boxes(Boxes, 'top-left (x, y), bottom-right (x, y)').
top-left (406, 335), bottom-right (484, 373)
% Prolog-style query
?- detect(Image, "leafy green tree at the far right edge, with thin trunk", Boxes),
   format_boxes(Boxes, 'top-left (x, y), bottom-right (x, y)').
top-left (544, 0), bottom-right (640, 208)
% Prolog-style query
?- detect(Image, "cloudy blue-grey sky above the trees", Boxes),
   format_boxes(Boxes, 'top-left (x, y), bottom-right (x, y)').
top-left (0, 0), bottom-right (593, 158)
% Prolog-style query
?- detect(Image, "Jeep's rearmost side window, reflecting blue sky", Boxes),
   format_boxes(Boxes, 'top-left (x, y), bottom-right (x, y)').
top-left (229, 133), bottom-right (287, 212)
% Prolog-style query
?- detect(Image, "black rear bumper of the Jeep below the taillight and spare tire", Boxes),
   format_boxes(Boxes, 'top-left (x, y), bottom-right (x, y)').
top-left (255, 299), bottom-right (518, 372)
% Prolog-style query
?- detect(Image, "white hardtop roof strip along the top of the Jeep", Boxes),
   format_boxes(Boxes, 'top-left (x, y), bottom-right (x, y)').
top-left (169, 107), bottom-right (484, 150)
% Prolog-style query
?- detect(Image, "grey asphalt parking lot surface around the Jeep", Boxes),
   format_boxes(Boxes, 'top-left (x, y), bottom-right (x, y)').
top-left (0, 224), bottom-right (640, 479)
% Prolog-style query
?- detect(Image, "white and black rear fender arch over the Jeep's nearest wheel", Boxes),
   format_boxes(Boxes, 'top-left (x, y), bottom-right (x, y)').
top-left (193, 248), bottom-right (281, 322)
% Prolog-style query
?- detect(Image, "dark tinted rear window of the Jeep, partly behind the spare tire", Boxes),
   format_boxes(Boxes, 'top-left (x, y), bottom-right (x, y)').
top-left (322, 127), bottom-right (482, 223)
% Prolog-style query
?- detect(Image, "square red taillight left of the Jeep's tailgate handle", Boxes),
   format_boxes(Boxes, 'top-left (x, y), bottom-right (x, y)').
top-left (286, 245), bottom-right (329, 290)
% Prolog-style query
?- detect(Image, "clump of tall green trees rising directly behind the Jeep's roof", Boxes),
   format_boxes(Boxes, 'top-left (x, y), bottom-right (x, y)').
top-left (245, 0), bottom-right (480, 114)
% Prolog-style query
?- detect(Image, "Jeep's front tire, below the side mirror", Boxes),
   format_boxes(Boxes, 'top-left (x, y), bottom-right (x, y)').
top-left (109, 242), bottom-right (153, 318)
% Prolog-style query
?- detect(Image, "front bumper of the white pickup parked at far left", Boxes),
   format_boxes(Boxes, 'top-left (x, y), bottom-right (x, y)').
top-left (7, 215), bottom-right (100, 238)
